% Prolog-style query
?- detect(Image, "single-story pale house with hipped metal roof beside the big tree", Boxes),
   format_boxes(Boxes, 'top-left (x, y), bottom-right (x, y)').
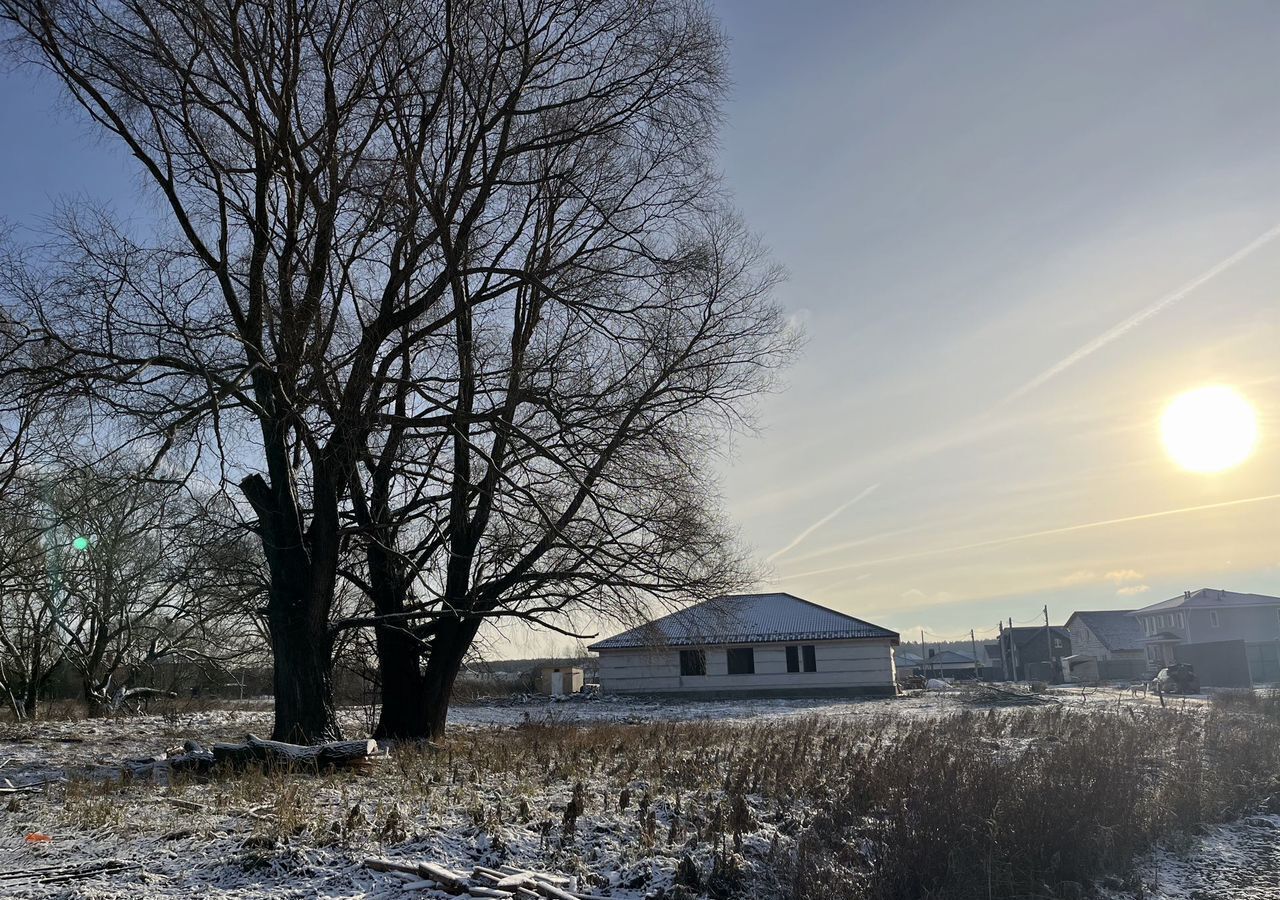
top-left (588, 593), bottom-right (899, 696)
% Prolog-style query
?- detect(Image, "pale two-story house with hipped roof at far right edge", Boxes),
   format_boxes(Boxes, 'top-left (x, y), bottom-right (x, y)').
top-left (1133, 588), bottom-right (1280, 684)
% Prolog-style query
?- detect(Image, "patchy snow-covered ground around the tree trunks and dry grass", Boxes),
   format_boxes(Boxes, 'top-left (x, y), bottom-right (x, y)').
top-left (0, 691), bottom-right (1280, 900)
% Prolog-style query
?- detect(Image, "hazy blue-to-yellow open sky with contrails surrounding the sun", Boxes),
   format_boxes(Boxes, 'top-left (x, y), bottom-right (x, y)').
top-left (0, 0), bottom-right (1280, 660)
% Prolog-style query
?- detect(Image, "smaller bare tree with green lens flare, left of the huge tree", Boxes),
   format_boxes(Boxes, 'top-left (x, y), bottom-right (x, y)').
top-left (41, 463), bottom-right (252, 712)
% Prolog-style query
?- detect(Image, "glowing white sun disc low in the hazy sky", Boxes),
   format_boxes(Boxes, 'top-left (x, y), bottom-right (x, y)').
top-left (1160, 385), bottom-right (1258, 472)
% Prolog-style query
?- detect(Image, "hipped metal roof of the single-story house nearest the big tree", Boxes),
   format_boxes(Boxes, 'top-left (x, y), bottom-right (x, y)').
top-left (588, 593), bottom-right (897, 650)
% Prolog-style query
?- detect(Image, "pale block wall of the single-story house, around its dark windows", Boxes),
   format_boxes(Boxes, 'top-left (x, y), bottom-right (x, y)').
top-left (600, 640), bottom-right (895, 694)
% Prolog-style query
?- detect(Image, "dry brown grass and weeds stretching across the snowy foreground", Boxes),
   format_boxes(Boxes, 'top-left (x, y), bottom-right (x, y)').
top-left (17, 695), bottom-right (1280, 900)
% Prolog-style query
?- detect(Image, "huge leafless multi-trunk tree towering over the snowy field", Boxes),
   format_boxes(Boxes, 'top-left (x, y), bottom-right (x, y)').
top-left (0, 0), bottom-right (786, 740)
